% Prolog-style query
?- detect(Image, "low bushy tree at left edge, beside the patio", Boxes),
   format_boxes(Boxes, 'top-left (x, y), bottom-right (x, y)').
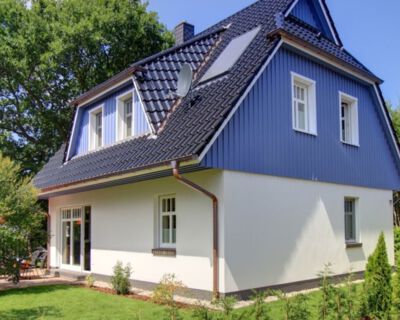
top-left (0, 154), bottom-right (46, 281)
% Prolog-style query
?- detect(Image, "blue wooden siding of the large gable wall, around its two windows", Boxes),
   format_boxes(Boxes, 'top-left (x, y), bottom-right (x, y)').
top-left (202, 48), bottom-right (400, 190)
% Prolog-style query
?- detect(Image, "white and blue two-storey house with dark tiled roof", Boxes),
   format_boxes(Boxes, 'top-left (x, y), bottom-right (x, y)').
top-left (34, 0), bottom-right (400, 297)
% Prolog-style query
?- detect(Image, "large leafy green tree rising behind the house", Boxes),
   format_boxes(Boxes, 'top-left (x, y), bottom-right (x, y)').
top-left (0, 0), bottom-right (172, 173)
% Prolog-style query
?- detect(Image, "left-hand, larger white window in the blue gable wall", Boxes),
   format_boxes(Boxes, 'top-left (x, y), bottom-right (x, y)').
top-left (292, 72), bottom-right (317, 135)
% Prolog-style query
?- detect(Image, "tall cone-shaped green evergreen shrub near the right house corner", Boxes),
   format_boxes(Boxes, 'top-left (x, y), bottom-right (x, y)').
top-left (361, 233), bottom-right (392, 319)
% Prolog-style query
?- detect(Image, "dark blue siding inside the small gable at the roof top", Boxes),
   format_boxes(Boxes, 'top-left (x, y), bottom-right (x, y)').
top-left (291, 0), bottom-right (333, 40)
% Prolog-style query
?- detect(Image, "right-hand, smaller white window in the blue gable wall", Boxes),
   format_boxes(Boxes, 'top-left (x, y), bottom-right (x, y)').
top-left (339, 92), bottom-right (359, 146)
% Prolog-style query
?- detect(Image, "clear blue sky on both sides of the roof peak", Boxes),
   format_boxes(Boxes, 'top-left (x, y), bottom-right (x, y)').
top-left (149, 0), bottom-right (400, 105)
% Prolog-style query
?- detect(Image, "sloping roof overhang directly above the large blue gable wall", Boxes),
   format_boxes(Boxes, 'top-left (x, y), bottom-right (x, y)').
top-left (267, 29), bottom-right (383, 84)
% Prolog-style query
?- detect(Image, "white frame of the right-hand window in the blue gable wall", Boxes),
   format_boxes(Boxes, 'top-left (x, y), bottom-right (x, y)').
top-left (339, 91), bottom-right (360, 147)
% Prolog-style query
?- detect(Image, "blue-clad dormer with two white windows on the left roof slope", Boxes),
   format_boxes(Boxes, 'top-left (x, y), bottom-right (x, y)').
top-left (66, 78), bottom-right (152, 161)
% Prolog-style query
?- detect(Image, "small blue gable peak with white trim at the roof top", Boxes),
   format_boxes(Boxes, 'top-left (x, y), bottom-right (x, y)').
top-left (286, 0), bottom-right (341, 45)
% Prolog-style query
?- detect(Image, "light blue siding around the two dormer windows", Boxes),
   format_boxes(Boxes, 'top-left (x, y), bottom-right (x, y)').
top-left (71, 84), bottom-right (150, 157)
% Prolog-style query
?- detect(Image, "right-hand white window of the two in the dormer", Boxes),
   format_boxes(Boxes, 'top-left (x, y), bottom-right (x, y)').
top-left (117, 92), bottom-right (134, 140)
